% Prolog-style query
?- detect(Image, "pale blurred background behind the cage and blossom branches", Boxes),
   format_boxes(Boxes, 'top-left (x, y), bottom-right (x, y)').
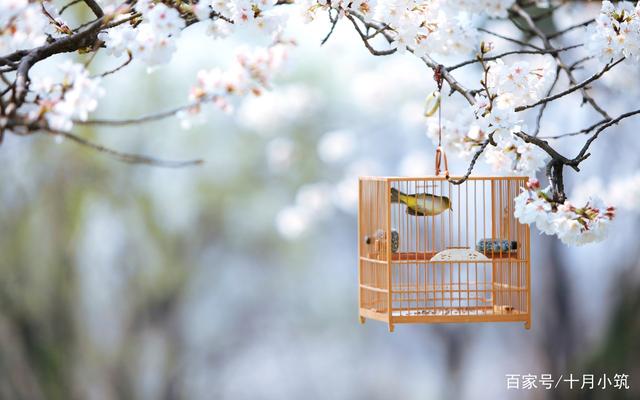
top-left (0, 1), bottom-right (640, 400)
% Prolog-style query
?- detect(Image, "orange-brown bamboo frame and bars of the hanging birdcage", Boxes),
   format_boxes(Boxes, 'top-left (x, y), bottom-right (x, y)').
top-left (358, 175), bottom-right (531, 332)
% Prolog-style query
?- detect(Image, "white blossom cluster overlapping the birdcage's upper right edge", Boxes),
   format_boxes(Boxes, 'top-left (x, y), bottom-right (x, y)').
top-left (514, 179), bottom-right (615, 246)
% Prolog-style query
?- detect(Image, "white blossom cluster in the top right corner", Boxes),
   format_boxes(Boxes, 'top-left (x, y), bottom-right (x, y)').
top-left (585, 1), bottom-right (640, 64)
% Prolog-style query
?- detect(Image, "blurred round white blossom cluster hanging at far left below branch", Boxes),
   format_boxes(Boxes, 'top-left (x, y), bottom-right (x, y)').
top-left (22, 61), bottom-right (104, 131)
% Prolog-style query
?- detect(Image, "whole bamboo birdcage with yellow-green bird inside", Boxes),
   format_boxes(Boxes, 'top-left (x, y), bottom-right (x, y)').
top-left (358, 176), bottom-right (531, 332)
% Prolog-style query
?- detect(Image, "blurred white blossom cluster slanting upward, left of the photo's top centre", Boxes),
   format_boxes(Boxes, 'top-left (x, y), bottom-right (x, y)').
top-left (181, 42), bottom-right (287, 127)
